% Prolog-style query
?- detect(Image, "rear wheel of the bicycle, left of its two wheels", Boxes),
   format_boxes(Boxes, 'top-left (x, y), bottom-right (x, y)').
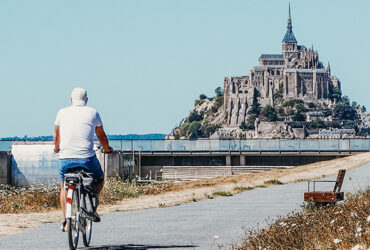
top-left (67, 190), bottom-right (79, 250)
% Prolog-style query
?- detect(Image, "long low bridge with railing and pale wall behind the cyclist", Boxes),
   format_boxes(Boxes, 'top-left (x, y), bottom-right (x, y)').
top-left (0, 139), bottom-right (370, 185)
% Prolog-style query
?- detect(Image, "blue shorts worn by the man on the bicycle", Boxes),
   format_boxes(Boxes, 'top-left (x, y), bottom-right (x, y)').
top-left (59, 155), bottom-right (104, 182)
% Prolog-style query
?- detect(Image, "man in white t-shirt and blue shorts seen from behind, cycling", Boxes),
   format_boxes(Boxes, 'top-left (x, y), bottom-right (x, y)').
top-left (54, 88), bottom-right (113, 231)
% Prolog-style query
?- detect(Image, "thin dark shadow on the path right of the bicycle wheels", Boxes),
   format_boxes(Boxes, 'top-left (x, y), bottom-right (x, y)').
top-left (81, 244), bottom-right (198, 250)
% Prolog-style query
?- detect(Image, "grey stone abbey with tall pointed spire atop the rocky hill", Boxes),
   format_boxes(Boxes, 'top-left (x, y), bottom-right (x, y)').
top-left (224, 6), bottom-right (340, 127)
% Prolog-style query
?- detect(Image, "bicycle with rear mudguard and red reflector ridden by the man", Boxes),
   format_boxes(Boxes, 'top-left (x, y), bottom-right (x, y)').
top-left (64, 167), bottom-right (92, 250)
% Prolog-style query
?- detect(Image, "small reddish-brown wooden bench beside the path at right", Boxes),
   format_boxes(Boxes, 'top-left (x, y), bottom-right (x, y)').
top-left (304, 169), bottom-right (346, 205)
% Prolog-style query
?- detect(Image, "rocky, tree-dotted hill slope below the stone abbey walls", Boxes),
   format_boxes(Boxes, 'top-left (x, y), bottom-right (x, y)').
top-left (172, 87), bottom-right (370, 139)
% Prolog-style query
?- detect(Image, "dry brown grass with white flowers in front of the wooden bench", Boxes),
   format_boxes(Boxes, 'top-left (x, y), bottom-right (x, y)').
top-left (238, 187), bottom-right (370, 249)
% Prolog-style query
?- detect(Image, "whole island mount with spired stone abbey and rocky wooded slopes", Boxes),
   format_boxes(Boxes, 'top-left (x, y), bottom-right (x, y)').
top-left (169, 6), bottom-right (370, 139)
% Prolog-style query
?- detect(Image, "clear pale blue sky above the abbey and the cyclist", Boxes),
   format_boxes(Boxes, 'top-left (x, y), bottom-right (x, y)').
top-left (0, 0), bottom-right (370, 137)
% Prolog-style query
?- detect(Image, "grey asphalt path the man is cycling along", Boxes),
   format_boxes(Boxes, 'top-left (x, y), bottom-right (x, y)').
top-left (0, 164), bottom-right (370, 250)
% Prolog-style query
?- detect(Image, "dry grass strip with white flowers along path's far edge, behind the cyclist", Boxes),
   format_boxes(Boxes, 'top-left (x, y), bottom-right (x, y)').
top-left (0, 173), bottom-right (274, 214)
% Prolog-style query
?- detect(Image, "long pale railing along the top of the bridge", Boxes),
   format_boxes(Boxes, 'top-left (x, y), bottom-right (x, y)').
top-left (110, 139), bottom-right (370, 152)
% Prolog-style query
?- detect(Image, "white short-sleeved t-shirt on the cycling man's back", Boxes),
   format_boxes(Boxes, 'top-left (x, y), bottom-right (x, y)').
top-left (55, 105), bottom-right (102, 159)
